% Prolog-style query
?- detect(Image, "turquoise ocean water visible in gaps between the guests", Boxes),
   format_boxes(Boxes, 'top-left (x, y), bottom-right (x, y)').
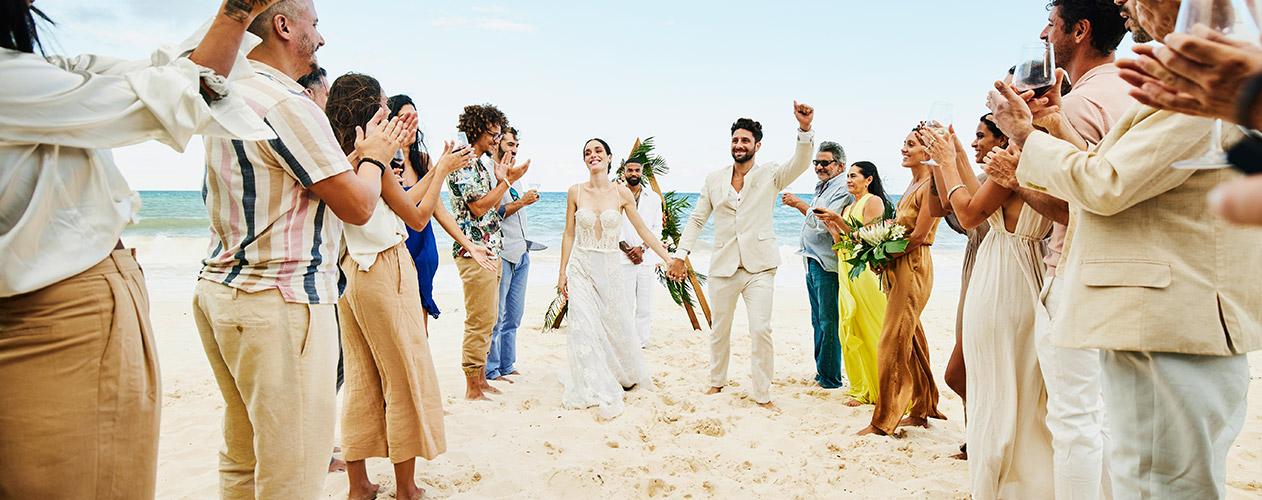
top-left (124, 191), bottom-right (968, 250)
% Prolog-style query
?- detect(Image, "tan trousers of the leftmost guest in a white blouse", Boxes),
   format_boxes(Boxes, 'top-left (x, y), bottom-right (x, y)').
top-left (0, 250), bottom-right (162, 499)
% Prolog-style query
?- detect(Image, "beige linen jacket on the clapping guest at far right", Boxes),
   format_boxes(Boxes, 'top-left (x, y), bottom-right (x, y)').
top-left (1017, 106), bottom-right (1262, 356)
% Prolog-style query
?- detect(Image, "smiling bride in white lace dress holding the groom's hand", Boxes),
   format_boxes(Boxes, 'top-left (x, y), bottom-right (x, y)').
top-left (557, 139), bottom-right (668, 418)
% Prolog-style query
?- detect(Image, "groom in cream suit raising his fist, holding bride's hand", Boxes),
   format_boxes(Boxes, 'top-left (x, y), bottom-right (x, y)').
top-left (669, 102), bottom-right (815, 409)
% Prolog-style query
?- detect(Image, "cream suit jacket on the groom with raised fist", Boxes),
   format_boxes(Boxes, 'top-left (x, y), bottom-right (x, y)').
top-left (676, 131), bottom-right (815, 278)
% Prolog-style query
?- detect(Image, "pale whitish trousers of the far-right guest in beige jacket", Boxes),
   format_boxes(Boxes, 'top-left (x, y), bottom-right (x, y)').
top-left (1100, 348), bottom-right (1249, 500)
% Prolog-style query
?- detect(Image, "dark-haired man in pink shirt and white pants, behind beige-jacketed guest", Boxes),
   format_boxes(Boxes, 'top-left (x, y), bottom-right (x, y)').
top-left (987, 0), bottom-right (1143, 499)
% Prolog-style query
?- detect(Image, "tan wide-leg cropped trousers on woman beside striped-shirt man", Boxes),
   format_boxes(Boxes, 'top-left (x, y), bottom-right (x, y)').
top-left (337, 242), bottom-right (447, 463)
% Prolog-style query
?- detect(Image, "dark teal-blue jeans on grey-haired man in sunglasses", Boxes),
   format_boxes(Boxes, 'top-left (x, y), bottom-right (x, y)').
top-left (805, 259), bottom-right (846, 389)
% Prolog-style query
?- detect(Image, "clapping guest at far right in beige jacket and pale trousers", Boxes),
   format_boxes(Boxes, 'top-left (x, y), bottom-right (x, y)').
top-left (992, 1), bottom-right (1262, 499)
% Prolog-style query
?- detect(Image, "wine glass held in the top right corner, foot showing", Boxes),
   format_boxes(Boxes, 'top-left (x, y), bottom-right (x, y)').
top-left (1171, 0), bottom-right (1258, 170)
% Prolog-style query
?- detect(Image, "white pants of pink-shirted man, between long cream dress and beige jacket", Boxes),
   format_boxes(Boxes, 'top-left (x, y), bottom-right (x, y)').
top-left (1035, 277), bottom-right (1111, 500)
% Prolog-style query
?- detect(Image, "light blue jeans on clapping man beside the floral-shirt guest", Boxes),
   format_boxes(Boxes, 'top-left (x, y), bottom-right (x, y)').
top-left (486, 251), bottom-right (530, 380)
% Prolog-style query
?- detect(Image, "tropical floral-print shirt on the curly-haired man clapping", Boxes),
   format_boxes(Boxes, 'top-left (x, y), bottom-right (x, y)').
top-left (447, 157), bottom-right (504, 256)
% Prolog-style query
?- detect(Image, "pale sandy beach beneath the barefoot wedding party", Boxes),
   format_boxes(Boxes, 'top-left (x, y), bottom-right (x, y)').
top-left (127, 237), bottom-right (1262, 499)
